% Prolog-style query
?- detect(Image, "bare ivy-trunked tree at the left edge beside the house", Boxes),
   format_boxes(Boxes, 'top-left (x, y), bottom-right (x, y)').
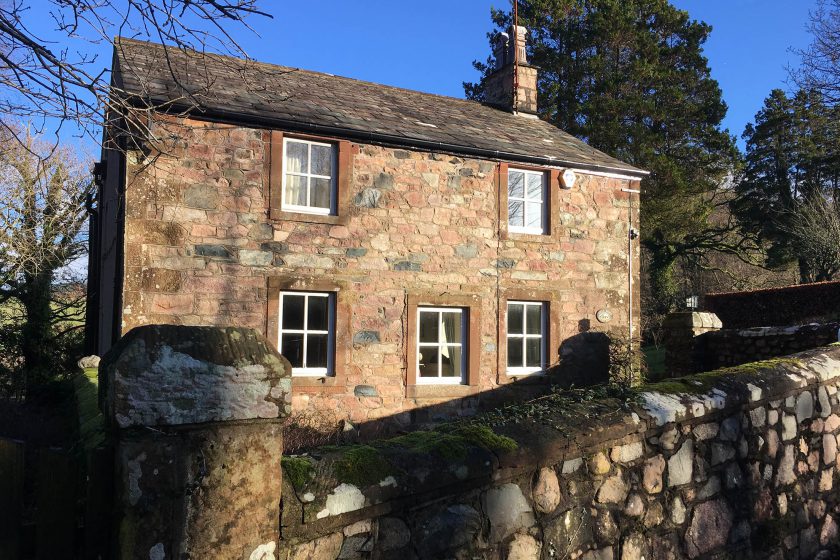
top-left (0, 127), bottom-right (92, 394)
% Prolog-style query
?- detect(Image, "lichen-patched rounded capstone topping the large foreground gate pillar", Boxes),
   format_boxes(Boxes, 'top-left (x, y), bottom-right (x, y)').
top-left (99, 325), bottom-right (291, 428)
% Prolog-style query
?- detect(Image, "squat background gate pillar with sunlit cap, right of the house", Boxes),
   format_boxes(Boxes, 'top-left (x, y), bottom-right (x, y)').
top-left (662, 311), bottom-right (723, 377)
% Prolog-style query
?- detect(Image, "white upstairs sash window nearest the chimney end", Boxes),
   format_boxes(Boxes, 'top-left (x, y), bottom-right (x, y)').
top-left (508, 169), bottom-right (548, 234)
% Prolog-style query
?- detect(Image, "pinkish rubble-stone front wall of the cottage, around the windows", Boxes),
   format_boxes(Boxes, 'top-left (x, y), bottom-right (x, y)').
top-left (122, 120), bottom-right (639, 422)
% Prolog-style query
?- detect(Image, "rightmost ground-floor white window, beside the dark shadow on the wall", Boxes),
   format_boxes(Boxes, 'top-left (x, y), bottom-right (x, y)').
top-left (507, 301), bottom-right (547, 375)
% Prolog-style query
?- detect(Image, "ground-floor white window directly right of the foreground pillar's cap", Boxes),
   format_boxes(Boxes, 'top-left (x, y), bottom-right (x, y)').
top-left (277, 292), bottom-right (335, 377)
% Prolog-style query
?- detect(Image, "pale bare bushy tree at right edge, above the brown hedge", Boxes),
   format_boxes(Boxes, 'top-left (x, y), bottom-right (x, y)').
top-left (785, 195), bottom-right (840, 282)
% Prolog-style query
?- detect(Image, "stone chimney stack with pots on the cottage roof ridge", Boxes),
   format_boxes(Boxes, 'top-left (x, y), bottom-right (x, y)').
top-left (485, 26), bottom-right (537, 115)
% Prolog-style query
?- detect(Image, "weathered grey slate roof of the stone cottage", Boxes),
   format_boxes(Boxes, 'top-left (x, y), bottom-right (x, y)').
top-left (114, 38), bottom-right (646, 176)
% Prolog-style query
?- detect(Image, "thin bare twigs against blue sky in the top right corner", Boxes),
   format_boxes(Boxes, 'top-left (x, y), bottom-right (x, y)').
top-left (791, 0), bottom-right (840, 104)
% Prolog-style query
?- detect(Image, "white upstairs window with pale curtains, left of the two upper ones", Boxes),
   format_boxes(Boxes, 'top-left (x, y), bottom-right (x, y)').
top-left (283, 138), bottom-right (336, 214)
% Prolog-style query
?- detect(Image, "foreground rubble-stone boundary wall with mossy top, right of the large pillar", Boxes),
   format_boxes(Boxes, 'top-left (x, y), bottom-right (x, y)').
top-left (279, 346), bottom-right (840, 560)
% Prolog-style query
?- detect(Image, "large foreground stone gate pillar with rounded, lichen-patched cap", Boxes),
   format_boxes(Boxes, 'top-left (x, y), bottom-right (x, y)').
top-left (99, 325), bottom-right (291, 560)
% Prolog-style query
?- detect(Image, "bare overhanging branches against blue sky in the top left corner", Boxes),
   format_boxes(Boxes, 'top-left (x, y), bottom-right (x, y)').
top-left (0, 0), bottom-right (267, 147)
